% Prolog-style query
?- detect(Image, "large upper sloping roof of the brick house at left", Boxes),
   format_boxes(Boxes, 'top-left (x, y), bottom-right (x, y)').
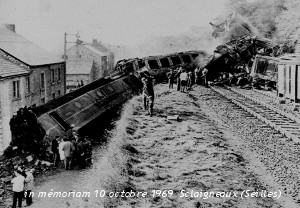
top-left (0, 28), bottom-right (64, 66)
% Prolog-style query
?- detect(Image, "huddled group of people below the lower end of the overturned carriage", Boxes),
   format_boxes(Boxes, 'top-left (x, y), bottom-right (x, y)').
top-left (51, 130), bottom-right (92, 170)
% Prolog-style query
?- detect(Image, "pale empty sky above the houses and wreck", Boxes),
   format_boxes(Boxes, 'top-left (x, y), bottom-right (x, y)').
top-left (0, 0), bottom-right (226, 52)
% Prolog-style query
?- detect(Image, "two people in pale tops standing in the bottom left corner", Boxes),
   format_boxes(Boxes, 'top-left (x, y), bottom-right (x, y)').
top-left (11, 166), bottom-right (34, 208)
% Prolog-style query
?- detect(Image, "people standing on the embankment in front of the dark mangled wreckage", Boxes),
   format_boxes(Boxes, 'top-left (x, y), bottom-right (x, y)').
top-left (167, 67), bottom-right (207, 92)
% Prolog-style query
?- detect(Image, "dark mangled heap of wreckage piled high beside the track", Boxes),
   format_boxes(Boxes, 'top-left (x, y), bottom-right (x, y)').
top-left (203, 35), bottom-right (276, 86)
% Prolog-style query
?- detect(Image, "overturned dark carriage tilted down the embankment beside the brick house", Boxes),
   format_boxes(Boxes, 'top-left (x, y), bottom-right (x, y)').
top-left (34, 75), bottom-right (142, 141)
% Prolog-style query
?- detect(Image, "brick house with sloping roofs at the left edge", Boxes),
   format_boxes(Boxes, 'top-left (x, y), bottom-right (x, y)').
top-left (0, 25), bottom-right (66, 151)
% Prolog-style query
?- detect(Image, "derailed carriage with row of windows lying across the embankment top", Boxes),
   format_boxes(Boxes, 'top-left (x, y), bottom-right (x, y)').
top-left (115, 50), bottom-right (207, 82)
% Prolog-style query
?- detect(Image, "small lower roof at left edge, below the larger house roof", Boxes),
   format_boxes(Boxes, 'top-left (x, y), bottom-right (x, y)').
top-left (0, 56), bottom-right (29, 78)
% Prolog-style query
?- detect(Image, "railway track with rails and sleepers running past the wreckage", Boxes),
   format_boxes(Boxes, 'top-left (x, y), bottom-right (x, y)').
top-left (211, 87), bottom-right (300, 143)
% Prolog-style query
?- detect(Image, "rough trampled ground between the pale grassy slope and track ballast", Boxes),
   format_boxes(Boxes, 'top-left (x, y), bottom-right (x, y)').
top-left (122, 85), bottom-right (291, 208)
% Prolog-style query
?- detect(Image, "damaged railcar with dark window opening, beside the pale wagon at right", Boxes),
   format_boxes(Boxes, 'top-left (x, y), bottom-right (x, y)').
top-left (250, 55), bottom-right (279, 90)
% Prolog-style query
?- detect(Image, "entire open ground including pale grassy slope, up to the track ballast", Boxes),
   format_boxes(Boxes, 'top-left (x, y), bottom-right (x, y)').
top-left (2, 84), bottom-right (298, 208)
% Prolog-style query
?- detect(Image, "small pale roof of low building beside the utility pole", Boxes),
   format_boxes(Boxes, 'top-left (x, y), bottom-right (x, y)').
top-left (66, 59), bottom-right (93, 75)
